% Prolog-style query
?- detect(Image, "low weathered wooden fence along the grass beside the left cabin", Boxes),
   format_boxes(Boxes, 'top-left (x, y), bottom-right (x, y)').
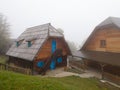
top-left (0, 63), bottom-right (32, 75)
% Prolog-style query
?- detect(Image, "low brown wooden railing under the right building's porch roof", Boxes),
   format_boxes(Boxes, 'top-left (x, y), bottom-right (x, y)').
top-left (103, 72), bottom-right (120, 85)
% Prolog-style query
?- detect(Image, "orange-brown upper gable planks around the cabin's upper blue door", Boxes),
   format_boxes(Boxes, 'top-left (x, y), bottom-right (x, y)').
top-left (37, 38), bottom-right (69, 60)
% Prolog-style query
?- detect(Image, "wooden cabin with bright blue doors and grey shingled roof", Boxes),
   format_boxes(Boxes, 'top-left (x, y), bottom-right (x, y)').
top-left (7, 23), bottom-right (71, 74)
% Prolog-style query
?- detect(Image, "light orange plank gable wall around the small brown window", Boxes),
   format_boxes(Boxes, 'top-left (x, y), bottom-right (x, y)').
top-left (85, 28), bottom-right (120, 53)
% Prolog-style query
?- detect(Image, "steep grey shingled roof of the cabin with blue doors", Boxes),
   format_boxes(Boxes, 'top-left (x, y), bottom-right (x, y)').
top-left (6, 23), bottom-right (64, 61)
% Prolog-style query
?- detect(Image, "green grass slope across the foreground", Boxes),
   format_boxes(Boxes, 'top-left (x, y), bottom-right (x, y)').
top-left (0, 71), bottom-right (115, 90)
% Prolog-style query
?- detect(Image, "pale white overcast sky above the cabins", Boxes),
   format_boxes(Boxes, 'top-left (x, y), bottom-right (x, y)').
top-left (0, 0), bottom-right (120, 45)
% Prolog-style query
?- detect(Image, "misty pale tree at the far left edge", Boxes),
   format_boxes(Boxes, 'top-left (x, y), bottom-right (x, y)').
top-left (0, 13), bottom-right (10, 54)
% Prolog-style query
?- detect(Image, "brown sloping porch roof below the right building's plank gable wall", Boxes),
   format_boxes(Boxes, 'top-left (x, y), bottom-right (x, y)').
top-left (73, 51), bottom-right (120, 66)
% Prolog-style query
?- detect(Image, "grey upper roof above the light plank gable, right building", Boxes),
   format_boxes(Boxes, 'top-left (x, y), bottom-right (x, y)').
top-left (80, 17), bottom-right (120, 50)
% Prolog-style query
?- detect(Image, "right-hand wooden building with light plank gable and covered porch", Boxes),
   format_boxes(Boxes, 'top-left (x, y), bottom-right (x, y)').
top-left (74, 17), bottom-right (120, 84)
